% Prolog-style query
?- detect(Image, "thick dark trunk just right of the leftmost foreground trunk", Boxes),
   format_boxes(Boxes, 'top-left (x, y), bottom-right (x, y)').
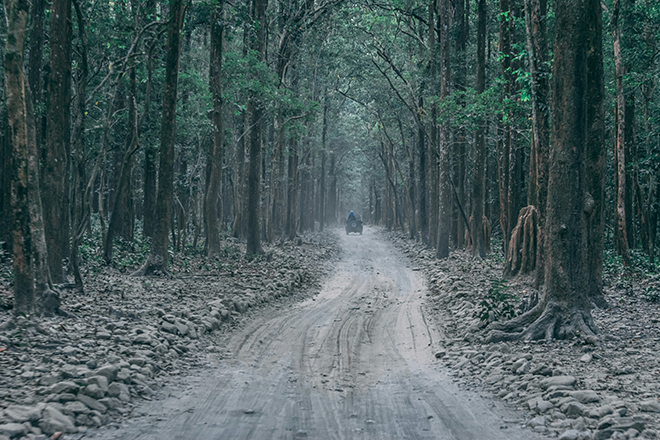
top-left (41, 0), bottom-right (72, 283)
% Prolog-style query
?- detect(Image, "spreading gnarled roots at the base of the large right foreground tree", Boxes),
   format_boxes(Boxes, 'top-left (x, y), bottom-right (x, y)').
top-left (486, 302), bottom-right (598, 343)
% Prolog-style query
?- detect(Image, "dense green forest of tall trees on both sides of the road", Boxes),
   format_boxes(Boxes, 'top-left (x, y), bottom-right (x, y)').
top-left (0, 0), bottom-right (660, 341)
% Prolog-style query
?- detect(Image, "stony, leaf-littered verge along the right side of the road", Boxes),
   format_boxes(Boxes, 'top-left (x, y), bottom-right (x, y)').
top-left (386, 233), bottom-right (660, 440)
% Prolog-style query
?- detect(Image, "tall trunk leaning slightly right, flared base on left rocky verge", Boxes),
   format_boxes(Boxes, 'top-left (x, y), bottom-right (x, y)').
top-left (136, 0), bottom-right (185, 275)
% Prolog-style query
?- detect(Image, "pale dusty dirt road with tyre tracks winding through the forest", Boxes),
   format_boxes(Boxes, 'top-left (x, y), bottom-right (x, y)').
top-left (86, 229), bottom-right (538, 440)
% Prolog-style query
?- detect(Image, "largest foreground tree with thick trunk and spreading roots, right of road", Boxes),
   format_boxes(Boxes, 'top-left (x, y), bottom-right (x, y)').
top-left (488, 0), bottom-right (603, 342)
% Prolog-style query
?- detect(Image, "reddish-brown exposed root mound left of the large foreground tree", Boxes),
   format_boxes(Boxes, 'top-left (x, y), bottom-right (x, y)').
top-left (504, 205), bottom-right (540, 276)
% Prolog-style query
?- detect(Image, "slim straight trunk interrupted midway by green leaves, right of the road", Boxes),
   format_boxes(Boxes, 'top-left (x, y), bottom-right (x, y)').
top-left (470, 0), bottom-right (487, 258)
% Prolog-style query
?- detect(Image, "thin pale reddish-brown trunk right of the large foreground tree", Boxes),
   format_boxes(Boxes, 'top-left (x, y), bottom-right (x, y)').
top-left (610, 0), bottom-right (632, 266)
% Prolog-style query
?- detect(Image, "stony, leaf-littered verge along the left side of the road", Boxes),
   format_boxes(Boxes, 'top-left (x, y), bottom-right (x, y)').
top-left (0, 233), bottom-right (339, 440)
